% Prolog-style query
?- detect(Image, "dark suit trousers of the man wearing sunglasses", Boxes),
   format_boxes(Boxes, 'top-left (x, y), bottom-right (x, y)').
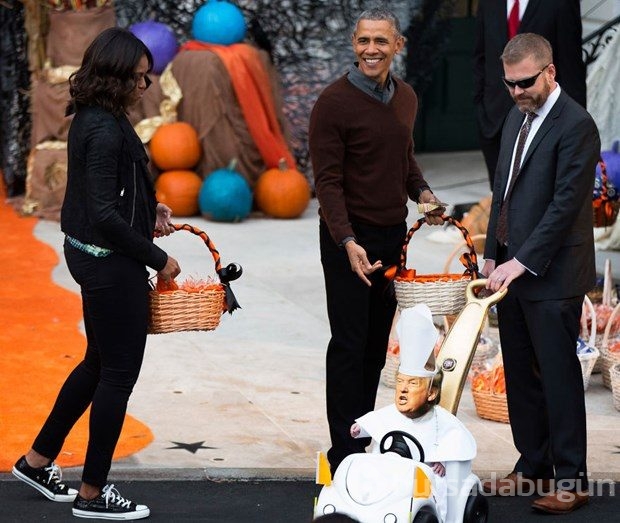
top-left (497, 290), bottom-right (588, 490)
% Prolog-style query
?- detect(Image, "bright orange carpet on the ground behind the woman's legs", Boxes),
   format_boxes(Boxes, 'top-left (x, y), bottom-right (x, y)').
top-left (0, 190), bottom-right (153, 472)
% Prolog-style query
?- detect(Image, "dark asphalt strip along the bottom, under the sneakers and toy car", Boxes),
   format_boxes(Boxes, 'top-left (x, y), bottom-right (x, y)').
top-left (0, 475), bottom-right (620, 523)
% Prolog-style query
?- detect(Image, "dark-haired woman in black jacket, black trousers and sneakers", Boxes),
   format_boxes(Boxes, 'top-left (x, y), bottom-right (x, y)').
top-left (13, 28), bottom-right (180, 519)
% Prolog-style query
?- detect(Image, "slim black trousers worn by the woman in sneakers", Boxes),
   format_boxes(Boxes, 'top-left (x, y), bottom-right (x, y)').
top-left (32, 243), bottom-right (149, 487)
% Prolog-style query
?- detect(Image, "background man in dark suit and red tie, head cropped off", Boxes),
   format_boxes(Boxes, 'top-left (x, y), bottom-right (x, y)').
top-left (474, 0), bottom-right (586, 189)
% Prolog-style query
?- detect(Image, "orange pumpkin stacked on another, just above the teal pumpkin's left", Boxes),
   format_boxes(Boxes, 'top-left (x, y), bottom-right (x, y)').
top-left (150, 122), bottom-right (200, 171)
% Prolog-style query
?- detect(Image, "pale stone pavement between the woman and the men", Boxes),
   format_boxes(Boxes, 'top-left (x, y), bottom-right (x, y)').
top-left (30, 152), bottom-right (620, 480)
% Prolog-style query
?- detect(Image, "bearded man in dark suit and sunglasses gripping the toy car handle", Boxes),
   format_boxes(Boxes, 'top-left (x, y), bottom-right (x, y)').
top-left (482, 33), bottom-right (600, 514)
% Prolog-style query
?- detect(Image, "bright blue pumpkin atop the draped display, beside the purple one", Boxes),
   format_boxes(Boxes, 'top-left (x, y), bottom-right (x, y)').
top-left (192, 0), bottom-right (247, 45)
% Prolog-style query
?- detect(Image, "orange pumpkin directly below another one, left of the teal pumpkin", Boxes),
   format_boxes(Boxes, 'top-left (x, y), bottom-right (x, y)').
top-left (155, 170), bottom-right (202, 216)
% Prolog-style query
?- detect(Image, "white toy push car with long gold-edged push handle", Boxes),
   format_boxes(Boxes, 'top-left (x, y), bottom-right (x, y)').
top-left (314, 279), bottom-right (506, 523)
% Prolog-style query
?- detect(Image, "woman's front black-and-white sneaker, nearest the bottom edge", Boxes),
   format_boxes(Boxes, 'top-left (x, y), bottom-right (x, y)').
top-left (73, 485), bottom-right (151, 520)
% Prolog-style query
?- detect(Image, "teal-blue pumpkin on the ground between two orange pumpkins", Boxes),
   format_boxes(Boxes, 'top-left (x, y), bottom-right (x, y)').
top-left (198, 162), bottom-right (252, 222)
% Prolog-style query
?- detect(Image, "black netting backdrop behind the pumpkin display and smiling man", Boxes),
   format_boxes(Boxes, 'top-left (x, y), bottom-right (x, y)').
top-left (0, 0), bottom-right (455, 194)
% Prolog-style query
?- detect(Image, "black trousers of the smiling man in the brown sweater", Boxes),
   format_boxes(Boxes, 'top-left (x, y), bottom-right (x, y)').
top-left (320, 221), bottom-right (407, 472)
